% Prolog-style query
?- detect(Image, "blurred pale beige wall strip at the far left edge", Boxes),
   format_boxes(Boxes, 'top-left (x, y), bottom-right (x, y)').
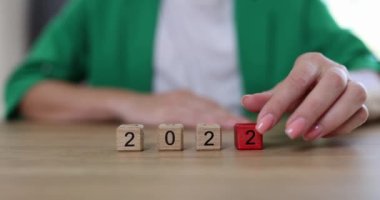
top-left (0, 0), bottom-right (27, 119)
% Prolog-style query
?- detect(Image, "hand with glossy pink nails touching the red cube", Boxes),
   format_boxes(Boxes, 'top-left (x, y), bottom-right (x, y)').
top-left (242, 53), bottom-right (368, 140)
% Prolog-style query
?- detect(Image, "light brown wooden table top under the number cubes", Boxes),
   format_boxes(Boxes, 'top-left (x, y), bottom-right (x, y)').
top-left (0, 122), bottom-right (380, 200)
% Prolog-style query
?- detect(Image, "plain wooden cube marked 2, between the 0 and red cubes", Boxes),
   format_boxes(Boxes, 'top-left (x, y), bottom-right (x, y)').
top-left (195, 124), bottom-right (222, 151)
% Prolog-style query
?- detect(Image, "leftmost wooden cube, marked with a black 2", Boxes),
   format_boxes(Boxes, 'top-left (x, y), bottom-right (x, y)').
top-left (116, 124), bottom-right (144, 151)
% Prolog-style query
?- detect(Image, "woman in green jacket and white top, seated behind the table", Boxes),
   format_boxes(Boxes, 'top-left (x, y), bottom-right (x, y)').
top-left (6, 0), bottom-right (380, 140)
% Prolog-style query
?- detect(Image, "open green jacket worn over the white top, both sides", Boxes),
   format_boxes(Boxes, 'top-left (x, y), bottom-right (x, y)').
top-left (5, 0), bottom-right (380, 119)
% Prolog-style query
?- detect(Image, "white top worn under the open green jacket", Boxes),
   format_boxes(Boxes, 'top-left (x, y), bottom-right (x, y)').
top-left (154, 0), bottom-right (242, 113)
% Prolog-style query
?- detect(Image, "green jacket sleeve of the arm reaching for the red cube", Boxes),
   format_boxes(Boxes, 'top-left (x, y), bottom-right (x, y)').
top-left (305, 0), bottom-right (380, 71)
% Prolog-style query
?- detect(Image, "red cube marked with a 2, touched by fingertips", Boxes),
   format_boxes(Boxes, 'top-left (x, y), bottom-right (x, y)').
top-left (234, 123), bottom-right (263, 150)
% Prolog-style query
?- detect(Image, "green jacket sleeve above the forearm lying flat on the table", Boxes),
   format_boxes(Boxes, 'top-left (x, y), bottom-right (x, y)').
top-left (5, 0), bottom-right (87, 119)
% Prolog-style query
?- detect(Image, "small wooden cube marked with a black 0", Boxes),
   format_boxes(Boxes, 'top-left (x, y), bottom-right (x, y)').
top-left (158, 124), bottom-right (183, 151)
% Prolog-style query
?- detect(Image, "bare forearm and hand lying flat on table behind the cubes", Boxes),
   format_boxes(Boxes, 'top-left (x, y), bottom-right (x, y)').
top-left (20, 80), bottom-right (248, 128)
